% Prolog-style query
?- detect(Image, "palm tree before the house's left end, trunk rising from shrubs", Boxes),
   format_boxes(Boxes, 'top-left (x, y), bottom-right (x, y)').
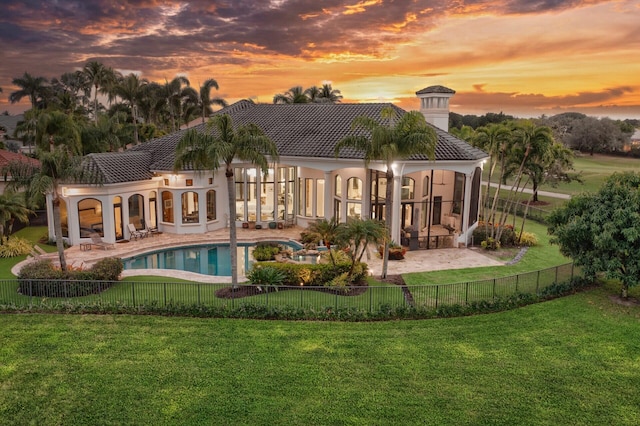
top-left (4, 144), bottom-right (99, 270)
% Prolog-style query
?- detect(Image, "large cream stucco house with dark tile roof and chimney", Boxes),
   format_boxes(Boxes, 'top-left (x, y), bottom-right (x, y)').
top-left (49, 86), bottom-right (488, 248)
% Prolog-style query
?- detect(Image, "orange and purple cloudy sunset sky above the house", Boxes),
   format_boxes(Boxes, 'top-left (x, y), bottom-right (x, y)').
top-left (0, 0), bottom-right (640, 118)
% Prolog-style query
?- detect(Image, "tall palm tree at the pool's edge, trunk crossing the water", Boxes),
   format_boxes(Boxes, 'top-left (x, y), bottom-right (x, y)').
top-left (174, 114), bottom-right (278, 288)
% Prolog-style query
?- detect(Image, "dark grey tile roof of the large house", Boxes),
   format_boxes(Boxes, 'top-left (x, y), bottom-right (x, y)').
top-left (86, 101), bottom-right (487, 183)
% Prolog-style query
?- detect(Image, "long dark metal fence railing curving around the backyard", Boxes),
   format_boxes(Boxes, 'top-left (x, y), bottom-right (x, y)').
top-left (0, 263), bottom-right (576, 312)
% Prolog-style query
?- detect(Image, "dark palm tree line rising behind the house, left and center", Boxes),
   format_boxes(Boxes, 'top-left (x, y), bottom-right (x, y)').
top-left (0, 61), bottom-right (342, 155)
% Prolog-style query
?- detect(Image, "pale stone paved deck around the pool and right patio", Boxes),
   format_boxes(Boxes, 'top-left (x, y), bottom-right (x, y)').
top-left (12, 227), bottom-right (504, 283)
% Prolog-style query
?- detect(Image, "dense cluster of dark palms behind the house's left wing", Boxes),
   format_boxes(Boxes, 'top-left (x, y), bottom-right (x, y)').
top-left (9, 61), bottom-right (227, 152)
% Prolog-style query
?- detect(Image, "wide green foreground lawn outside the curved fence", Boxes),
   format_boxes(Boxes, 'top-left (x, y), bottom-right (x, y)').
top-left (0, 289), bottom-right (640, 425)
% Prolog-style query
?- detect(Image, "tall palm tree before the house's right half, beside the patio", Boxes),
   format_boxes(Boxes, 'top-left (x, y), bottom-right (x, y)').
top-left (335, 106), bottom-right (437, 278)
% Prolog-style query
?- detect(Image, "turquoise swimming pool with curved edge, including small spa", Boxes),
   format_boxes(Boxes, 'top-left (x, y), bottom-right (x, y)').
top-left (122, 241), bottom-right (302, 277)
